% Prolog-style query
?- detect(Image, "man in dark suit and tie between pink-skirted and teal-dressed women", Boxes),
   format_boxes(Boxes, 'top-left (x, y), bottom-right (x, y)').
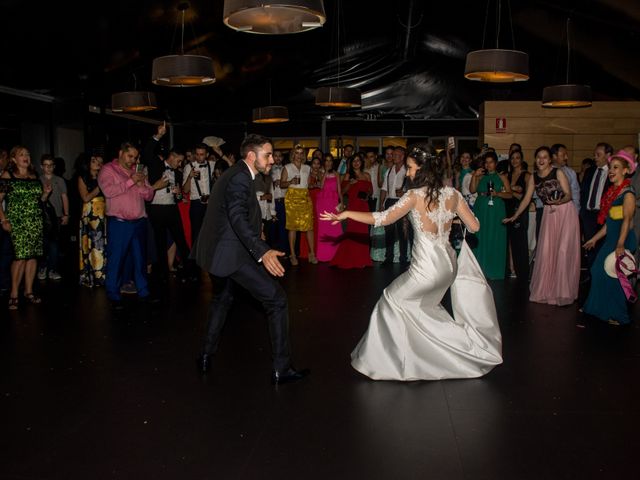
top-left (580, 143), bottom-right (613, 267)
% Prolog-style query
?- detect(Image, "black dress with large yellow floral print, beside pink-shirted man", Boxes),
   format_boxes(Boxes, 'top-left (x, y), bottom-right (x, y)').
top-left (79, 175), bottom-right (107, 287)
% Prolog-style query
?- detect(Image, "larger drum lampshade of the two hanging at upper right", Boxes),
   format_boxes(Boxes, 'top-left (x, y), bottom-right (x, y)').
top-left (464, 48), bottom-right (529, 83)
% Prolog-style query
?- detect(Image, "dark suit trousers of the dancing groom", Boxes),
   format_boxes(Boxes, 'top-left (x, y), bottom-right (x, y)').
top-left (203, 261), bottom-right (291, 372)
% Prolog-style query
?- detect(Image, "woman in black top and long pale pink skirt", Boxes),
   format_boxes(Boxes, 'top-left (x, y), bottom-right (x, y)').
top-left (504, 147), bottom-right (580, 305)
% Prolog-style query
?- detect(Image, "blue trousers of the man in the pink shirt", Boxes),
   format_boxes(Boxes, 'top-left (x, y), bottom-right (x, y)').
top-left (105, 217), bottom-right (149, 301)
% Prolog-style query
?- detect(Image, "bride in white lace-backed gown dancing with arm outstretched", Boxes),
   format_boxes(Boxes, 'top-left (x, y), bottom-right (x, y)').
top-left (320, 147), bottom-right (502, 381)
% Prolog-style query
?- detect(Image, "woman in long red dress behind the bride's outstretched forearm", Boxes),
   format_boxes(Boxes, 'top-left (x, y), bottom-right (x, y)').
top-left (331, 155), bottom-right (373, 268)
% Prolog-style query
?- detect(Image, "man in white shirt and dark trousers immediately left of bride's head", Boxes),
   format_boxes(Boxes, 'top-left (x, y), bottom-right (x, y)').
top-left (380, 147), bottom-right (408, 265)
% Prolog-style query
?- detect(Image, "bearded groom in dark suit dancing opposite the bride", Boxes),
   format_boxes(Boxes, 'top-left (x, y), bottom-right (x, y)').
top-left (191, 134), bottom-right (309, 385)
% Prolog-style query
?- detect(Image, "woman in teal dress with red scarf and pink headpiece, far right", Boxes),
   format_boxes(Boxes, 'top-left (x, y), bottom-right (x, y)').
top-left (582, 150), bottom-right (638, 325)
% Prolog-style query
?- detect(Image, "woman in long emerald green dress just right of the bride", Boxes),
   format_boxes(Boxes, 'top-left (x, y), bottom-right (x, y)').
top-left (469, 152), bottom-right (512, 280)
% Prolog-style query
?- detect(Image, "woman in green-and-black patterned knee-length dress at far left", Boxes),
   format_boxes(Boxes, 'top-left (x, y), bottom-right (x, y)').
top-left (0, 145), bottom-right (51, 310)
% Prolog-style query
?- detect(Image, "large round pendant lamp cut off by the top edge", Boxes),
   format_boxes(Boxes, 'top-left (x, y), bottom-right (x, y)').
top-left (222, 0), bottom-right (327, 35)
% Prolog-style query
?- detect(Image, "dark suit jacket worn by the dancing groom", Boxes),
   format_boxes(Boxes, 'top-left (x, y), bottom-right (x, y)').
top-left (191, 161), bottom-right (270, 277)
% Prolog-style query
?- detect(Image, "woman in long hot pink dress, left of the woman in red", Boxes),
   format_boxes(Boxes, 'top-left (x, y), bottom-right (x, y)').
top-left (314, 153), bottom-right (342, 262)
